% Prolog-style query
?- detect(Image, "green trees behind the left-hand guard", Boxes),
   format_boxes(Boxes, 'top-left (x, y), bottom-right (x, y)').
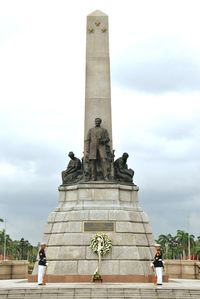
top-left (0, 230), bottom-right (38, 263)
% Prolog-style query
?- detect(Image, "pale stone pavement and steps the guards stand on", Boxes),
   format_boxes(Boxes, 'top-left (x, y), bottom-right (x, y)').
top-left (0, 279), bottom-right (200, 299)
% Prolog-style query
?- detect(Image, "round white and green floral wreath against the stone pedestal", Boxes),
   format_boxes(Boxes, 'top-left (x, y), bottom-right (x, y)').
top-left (90, 233), bottom-right (112, 256)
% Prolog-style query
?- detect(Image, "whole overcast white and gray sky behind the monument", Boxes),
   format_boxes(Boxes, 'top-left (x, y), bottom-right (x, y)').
top-left (0, 0), bottom-right (200, 244)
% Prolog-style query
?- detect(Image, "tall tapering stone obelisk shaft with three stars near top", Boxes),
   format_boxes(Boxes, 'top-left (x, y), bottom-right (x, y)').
top-left (84, 10), bottom-right (112, 151)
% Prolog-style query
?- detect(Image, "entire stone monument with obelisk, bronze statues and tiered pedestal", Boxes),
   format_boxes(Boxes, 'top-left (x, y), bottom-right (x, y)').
top-left (29, 11), bottom-right (162, 282)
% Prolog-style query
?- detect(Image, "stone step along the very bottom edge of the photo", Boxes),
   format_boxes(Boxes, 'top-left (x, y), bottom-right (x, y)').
top-left (0, 287), bottom-right (200, 299)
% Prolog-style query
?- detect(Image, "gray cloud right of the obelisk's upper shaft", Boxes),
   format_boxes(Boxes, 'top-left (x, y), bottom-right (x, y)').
top-left (112, 35), bottom-right (200, 93)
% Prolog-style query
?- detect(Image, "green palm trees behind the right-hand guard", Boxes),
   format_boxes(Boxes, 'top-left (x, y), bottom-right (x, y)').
top-left (156, 230), bottom-right (200, 260)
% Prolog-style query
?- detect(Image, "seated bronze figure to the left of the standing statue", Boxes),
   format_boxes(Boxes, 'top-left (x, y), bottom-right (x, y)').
top-left (61, 152), bottom-right (82, 184)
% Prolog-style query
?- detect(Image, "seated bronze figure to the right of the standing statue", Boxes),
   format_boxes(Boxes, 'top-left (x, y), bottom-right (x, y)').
top-left (114, 153), bottom-right (134, 183)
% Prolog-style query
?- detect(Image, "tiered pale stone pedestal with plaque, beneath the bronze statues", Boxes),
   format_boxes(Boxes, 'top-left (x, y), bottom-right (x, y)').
top-left (29, 182), bottom-right (165, 282)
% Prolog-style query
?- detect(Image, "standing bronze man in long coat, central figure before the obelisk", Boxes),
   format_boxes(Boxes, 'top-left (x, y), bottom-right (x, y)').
top-left (85, 118), bottom-right (110, 181)
